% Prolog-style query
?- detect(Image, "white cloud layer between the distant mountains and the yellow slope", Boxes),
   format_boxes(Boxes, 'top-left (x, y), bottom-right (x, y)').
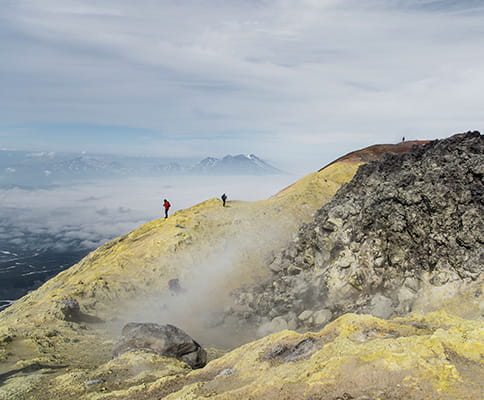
top-left (0, 175), bottom-right (296, 249)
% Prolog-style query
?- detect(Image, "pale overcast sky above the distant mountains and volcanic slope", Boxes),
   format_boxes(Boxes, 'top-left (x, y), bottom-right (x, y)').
top-left (0, 0), bottom-right (484, 170)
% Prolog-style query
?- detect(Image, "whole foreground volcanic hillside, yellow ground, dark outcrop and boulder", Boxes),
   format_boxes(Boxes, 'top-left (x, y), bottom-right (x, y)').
top-left (0, 132), bottom-right (484, 400)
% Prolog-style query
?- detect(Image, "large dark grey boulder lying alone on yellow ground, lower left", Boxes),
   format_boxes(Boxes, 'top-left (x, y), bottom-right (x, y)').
top-left (113, 322), bottom-right (207, 368)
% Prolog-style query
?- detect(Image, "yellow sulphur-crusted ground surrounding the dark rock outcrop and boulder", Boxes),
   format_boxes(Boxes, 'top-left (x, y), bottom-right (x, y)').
top-left (0, 134), bottom-right (484, 400)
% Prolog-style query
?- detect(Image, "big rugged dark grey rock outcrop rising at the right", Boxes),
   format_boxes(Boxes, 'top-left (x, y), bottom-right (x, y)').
top-left (234, 132), bottom-right (484, 328)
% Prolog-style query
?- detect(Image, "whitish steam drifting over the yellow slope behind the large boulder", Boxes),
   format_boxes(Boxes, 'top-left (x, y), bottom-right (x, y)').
top-left (117, 206), bottom-right (292, 348)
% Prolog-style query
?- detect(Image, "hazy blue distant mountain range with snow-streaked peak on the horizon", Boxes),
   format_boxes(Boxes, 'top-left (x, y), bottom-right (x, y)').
top-left (0, 150), bottom-right (283, 187)
